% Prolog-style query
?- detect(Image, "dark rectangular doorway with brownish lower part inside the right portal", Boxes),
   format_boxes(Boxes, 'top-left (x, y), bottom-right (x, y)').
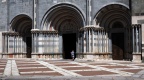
top-left (112, 33), bottom-right (124, 60)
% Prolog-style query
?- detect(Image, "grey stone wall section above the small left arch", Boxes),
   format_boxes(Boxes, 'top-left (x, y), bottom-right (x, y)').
top-left (7, 0), bottom-right (33, 22)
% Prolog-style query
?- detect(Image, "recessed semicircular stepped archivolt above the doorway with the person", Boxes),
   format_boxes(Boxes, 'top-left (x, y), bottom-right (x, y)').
top-left (42, 5), bottom-right (85, 31)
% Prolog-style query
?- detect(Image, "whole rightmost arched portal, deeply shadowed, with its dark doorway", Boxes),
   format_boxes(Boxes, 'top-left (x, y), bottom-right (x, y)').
top-left (95, 4), bottom-right (132, 60)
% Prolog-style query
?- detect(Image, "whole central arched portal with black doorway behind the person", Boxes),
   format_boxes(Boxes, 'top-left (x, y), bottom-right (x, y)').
top-left (42, 3), bottom-right (85, 59)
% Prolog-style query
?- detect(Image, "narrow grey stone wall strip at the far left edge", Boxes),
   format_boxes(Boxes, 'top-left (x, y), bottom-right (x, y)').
top-left (0, 0), bottom-right (7, 31)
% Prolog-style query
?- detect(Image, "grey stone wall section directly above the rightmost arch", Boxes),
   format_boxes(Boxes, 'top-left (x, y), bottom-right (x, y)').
top-left (92, 0), bottom-right (129, 20)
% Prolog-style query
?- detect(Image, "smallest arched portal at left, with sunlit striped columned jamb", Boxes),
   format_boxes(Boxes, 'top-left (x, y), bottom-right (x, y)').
top-left (4, 14), bottom-right (32, 58)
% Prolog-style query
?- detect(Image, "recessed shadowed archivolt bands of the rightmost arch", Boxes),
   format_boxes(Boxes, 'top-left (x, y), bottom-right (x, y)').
top-left (95, 4), bottom-right (131, 28)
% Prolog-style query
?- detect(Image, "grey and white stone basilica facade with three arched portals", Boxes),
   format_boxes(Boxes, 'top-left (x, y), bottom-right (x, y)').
top-left (0, 0), bottom-right (144, 62)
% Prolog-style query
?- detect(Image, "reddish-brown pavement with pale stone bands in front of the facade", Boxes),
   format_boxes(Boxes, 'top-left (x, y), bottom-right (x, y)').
top-left (0, 59), bottom-right (144, 80)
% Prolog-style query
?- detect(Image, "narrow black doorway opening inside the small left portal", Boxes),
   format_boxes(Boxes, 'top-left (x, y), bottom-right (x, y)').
top-left (26, 37), bottom-right (32, 58)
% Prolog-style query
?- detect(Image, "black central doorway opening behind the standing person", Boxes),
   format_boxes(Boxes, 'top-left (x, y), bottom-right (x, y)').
top-left (63, 33), bottom-right (76, 59)
